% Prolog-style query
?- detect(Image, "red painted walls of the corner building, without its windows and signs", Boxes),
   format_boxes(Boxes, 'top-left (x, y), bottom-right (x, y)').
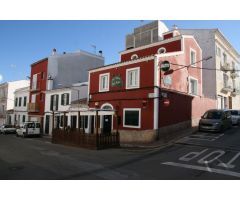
top-left (89, 28), bottom-right (215, 138)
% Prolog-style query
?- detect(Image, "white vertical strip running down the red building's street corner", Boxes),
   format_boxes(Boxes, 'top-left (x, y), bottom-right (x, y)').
top-left (153, 56), bottom-right (159, 139)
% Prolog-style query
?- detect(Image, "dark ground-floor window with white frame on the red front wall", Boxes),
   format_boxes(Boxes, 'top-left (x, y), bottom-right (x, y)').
top-left (123, 108), bottom-right (141, 128)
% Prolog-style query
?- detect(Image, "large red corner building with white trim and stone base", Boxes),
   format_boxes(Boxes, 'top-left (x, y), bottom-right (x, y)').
top-left (89, 30), bottom-right (216, 142)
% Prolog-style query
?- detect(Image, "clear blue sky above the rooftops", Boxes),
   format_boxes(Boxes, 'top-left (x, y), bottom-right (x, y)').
top-left (0, 20), bottom-right (240, 82)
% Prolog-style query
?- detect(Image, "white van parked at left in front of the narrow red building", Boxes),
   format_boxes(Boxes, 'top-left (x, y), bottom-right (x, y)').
top-left (16, 122), bottom-right (41, 137)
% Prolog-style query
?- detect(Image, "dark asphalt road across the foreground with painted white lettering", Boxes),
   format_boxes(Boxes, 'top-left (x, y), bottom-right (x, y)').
top-left (0, 127), bottom-right (240, 180)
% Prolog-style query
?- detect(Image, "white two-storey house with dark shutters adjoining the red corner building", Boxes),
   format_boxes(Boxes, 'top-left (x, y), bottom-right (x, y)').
top-left (43, 82), bottom-right (89, 135)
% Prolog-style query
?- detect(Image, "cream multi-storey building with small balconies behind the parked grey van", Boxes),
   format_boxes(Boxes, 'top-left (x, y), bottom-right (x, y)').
top-left (180, 29), bottom-right (240, 109)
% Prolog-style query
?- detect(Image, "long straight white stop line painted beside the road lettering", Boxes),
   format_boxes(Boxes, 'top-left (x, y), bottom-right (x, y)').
top-left (162, 162), bottom-right (240, 178)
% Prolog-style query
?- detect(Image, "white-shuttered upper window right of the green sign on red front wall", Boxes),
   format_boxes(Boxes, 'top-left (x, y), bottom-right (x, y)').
top-left (126, 67), bottom-right (140, 89)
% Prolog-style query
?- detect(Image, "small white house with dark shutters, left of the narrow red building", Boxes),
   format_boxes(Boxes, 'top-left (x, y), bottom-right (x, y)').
top-left (12, 87), bottom-right (29, 125)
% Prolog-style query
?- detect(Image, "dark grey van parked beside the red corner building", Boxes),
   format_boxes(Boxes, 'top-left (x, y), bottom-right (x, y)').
top-left (199, 109), bottom-right (232, 132)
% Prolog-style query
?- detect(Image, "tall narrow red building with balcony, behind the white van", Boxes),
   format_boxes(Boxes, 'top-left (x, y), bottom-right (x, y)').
top-left (28, 58), bottom-right (48, 124)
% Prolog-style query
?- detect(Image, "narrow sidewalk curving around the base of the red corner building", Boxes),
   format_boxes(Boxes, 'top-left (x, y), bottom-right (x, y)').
top-left (121, 127), bottom-right (198, 149)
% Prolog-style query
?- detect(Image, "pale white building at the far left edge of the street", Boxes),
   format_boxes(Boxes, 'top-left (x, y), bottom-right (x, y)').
top-left (0, 80), bottom-right (29, 125)
